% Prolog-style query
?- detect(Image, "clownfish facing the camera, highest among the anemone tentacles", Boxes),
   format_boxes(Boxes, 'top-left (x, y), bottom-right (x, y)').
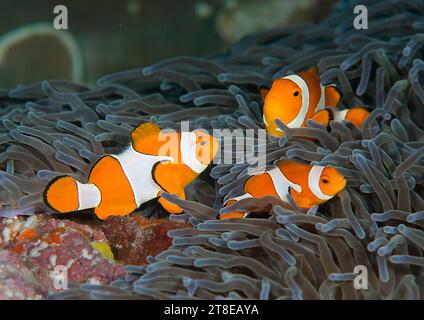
top-left (261, 67), bottom-right (368, 137)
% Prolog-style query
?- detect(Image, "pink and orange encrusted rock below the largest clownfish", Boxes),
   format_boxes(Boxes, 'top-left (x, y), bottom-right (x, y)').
top-left (0, 216), bottom-right (124, 299)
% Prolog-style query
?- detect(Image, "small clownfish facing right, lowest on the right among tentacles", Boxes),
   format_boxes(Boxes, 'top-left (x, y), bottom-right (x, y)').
top-left (220, 160), bottom-right (347, 219)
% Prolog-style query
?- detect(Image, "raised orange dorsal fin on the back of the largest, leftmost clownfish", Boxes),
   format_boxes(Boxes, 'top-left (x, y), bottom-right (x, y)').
top-left (131, 122), bottom-right (161, 155)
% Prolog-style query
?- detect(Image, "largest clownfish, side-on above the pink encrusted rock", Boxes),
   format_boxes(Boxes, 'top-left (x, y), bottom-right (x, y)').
top-left (43, 123), bottom-right (218, 220)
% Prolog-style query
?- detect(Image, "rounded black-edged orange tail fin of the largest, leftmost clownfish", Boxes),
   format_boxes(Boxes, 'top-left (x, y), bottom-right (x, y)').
top-left (43, 176), bottom-right (79, 213)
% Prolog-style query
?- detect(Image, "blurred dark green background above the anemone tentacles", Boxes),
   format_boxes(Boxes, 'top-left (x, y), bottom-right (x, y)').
top-left (0, 0), bottom-right (333, 87)
